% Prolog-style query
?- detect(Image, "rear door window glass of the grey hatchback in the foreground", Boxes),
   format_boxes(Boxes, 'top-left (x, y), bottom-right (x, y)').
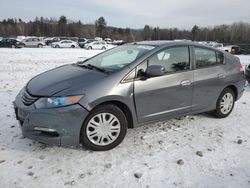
top-left (194, 47), bottom-right (224, 68)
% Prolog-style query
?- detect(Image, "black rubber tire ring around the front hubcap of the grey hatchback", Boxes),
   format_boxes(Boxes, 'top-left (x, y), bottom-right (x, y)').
top-left (80, 104), bottom-right (128, 151)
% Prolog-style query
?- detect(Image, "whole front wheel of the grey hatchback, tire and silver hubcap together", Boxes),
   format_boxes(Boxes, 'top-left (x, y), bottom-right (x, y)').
top-left (80, 104), bottom-right (128, 151)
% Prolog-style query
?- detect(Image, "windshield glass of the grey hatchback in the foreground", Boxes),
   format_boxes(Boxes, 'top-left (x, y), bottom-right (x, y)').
top-left (84, 44), bottom-right (154, 71)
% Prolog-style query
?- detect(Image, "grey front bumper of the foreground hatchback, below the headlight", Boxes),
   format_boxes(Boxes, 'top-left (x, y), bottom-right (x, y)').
top-left (14, 89), bottom-right (88, 146)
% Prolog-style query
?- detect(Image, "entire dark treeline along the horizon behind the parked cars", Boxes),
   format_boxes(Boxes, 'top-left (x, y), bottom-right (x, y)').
top-left (0, 16), bottom-right (250, 43)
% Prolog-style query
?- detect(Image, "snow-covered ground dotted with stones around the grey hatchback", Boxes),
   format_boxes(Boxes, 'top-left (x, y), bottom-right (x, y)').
top-left (0, 48), bottom-right (250, 188)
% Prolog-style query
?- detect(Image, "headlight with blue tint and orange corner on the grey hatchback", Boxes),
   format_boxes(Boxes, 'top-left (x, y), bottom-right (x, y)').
top-left (35, 95), bottom-right (83, 108)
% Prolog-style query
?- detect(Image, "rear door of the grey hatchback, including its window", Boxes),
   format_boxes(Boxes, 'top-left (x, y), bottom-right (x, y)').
top-left (193, 47), bottom-right (227, 111)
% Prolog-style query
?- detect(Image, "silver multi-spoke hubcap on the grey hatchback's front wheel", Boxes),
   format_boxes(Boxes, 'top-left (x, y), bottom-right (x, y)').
top-left (86, 113), bottom-right (121, 146)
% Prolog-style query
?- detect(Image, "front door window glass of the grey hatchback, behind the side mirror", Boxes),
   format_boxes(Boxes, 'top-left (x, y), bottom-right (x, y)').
top-left (148, 46), bottom-right (190, 73)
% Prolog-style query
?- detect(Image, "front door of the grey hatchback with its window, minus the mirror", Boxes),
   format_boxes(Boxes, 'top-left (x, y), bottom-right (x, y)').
top-left (134, 46), bottom-right (193, 123)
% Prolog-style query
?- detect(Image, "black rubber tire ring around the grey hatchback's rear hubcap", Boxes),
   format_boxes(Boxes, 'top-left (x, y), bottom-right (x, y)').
top-left (215, 88), bottom-right (235, 118)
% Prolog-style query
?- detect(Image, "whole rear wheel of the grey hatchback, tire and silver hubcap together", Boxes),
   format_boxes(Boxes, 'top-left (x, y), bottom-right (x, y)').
top-left (213, 88), bottom-right (235, 118)
